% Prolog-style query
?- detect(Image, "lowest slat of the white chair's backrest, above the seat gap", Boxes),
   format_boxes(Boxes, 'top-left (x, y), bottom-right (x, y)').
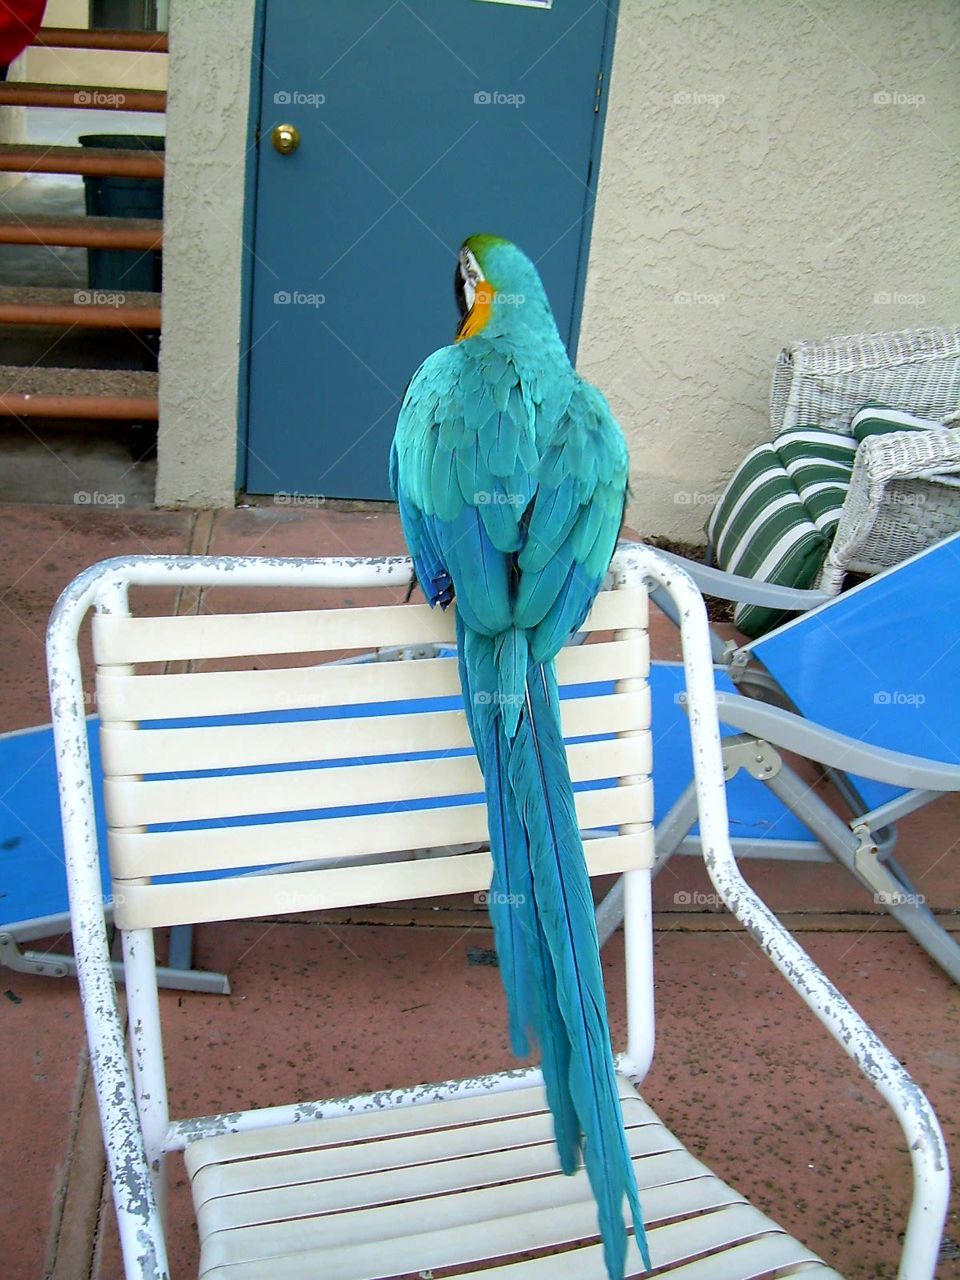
top-left (114, 828), bottom-right (653, 929)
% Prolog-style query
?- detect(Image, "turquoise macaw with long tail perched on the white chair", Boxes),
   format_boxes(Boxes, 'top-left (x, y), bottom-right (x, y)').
top-left (390, 236), bottom-right (650, 1280)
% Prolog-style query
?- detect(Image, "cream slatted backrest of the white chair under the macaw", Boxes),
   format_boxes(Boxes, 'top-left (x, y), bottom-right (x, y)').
top-left (93, 582), bottom-right (653, 929)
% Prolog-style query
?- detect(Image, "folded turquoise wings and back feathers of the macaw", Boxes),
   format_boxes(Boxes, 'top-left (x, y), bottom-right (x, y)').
top-left (392, 339), bottom-right (628, 640)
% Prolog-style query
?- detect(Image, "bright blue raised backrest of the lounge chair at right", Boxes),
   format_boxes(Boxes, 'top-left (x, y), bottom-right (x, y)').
top-left (744, 534), bottom-right (960, 808)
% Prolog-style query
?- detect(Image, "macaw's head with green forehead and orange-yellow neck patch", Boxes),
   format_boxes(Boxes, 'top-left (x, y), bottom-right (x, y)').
top-left (453, 236), bottom-right (559, 342)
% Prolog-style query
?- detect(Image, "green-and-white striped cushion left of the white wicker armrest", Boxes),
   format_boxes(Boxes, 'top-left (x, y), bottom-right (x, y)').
top-left (707, 426), bottom-right (856, 636)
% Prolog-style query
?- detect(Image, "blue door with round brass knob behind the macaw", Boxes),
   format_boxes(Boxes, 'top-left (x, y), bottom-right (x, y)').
top-left (239, 0), bottom-right (616, 499)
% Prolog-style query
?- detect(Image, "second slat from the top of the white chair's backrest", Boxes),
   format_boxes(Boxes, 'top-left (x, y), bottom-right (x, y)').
top-left (97, 634), bottom-right (649, 721)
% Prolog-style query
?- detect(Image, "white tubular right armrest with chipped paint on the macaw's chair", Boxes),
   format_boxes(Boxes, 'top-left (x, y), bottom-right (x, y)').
top-left (614, 548), bottom-right (950, 1280)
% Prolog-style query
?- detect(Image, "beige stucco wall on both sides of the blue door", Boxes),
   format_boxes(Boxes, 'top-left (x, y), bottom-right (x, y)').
top-left (157, 0), bottom-right (960, 519)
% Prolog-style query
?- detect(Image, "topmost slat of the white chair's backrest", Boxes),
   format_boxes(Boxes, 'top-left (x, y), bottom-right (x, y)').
top-left (93, 589), bottom-right (646, 666)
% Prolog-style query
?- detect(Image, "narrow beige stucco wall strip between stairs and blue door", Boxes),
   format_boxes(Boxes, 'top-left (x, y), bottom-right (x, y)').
top-left (156, 0), bottom-right (253, 507)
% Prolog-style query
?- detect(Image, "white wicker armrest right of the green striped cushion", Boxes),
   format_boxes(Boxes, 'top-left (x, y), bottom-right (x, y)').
top-left (819, 428), bottom-right (960, 594)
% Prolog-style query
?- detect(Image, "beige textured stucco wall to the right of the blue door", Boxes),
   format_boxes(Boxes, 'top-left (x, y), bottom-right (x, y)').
top-left (579, 0), bottom-right (960, 541)
